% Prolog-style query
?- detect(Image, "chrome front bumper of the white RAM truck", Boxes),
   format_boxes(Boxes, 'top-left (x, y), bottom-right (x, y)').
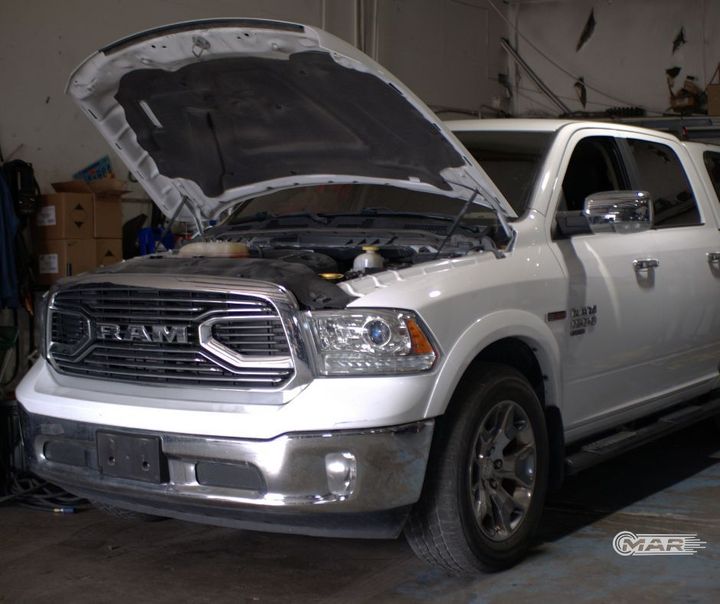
top-left (23, 412), bottom-right (434, 512)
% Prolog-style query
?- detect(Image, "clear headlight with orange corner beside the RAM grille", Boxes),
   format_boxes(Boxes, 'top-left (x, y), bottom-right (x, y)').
top-left (308, 309), bottom-right (437, 375)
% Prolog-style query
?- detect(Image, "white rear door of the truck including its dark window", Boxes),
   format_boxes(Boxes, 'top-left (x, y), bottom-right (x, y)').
top-left (625, 136), bottom-right (720, 394)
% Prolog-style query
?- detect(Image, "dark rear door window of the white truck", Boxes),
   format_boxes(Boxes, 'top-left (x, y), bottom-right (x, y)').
top-left (627, 139), bottom-right (702, 229)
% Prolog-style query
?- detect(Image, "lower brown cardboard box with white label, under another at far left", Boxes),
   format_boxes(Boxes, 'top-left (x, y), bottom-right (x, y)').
top-left (36, 239), bottom-right (96, 285)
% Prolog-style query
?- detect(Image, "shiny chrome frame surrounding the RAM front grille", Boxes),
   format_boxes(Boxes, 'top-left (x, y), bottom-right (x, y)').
top-left (46, 273), bottom-right (313, 402)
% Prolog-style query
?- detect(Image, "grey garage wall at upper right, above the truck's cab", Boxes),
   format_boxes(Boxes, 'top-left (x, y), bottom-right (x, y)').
top-left (510, 0), bottom-right (720, 114)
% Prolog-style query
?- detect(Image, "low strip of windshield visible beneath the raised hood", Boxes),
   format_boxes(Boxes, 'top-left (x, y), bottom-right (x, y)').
top-left (224, 185), bottom-right (497, 227)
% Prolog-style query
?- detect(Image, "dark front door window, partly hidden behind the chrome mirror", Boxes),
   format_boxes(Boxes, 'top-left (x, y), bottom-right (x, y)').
top-left (558, 136), bottom-right (628, 212)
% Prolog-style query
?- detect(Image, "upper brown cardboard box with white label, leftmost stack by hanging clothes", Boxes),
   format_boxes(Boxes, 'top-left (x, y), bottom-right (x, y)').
top-left (33, 193), bottom-right (94, 241)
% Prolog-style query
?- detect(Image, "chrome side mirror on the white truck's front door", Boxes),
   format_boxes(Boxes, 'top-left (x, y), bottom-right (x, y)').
top-left (583, 191), bottom-right (653, 233)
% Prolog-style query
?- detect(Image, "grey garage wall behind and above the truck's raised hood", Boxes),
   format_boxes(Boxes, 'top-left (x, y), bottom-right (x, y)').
top-left (0, 0), bottom-right (505, 195)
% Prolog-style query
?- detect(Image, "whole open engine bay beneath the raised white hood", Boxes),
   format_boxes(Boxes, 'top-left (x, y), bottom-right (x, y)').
top-left (93, 185), bottom-right (507, 310)
